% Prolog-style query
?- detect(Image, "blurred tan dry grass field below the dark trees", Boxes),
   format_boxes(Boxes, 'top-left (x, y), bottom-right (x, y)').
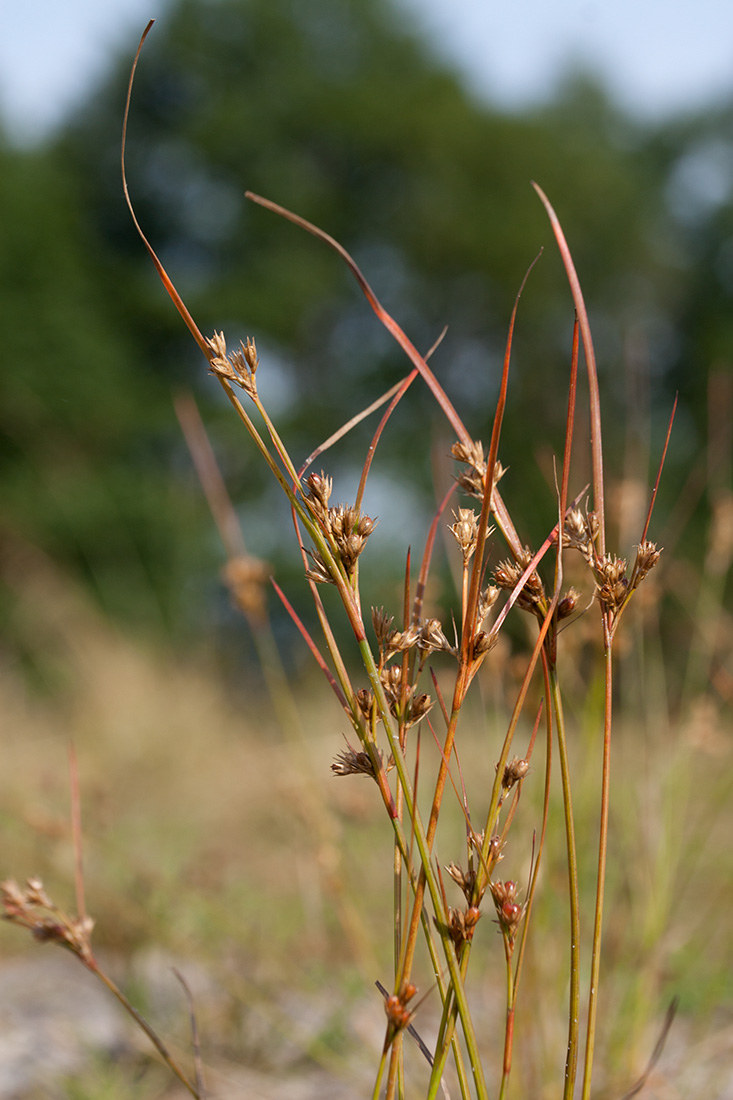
top-left (0, 536), bottom-right (733, 1100)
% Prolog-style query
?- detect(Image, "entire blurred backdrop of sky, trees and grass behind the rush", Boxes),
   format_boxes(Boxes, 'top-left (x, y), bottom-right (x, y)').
top-left (0, 0), bottom-right (733, 1098)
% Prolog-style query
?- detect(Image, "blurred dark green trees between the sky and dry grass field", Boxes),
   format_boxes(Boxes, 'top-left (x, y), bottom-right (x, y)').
top-left (0, 0), bottom-right (731, 660)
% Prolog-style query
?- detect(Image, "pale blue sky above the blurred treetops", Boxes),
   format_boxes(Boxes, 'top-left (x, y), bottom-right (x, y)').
top-left (0, 0), bottom-right (733, 141)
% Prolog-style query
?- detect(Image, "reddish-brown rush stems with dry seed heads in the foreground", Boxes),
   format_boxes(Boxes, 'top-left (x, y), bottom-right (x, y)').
top-left (6, 19), bottom-right (667, 1100)
